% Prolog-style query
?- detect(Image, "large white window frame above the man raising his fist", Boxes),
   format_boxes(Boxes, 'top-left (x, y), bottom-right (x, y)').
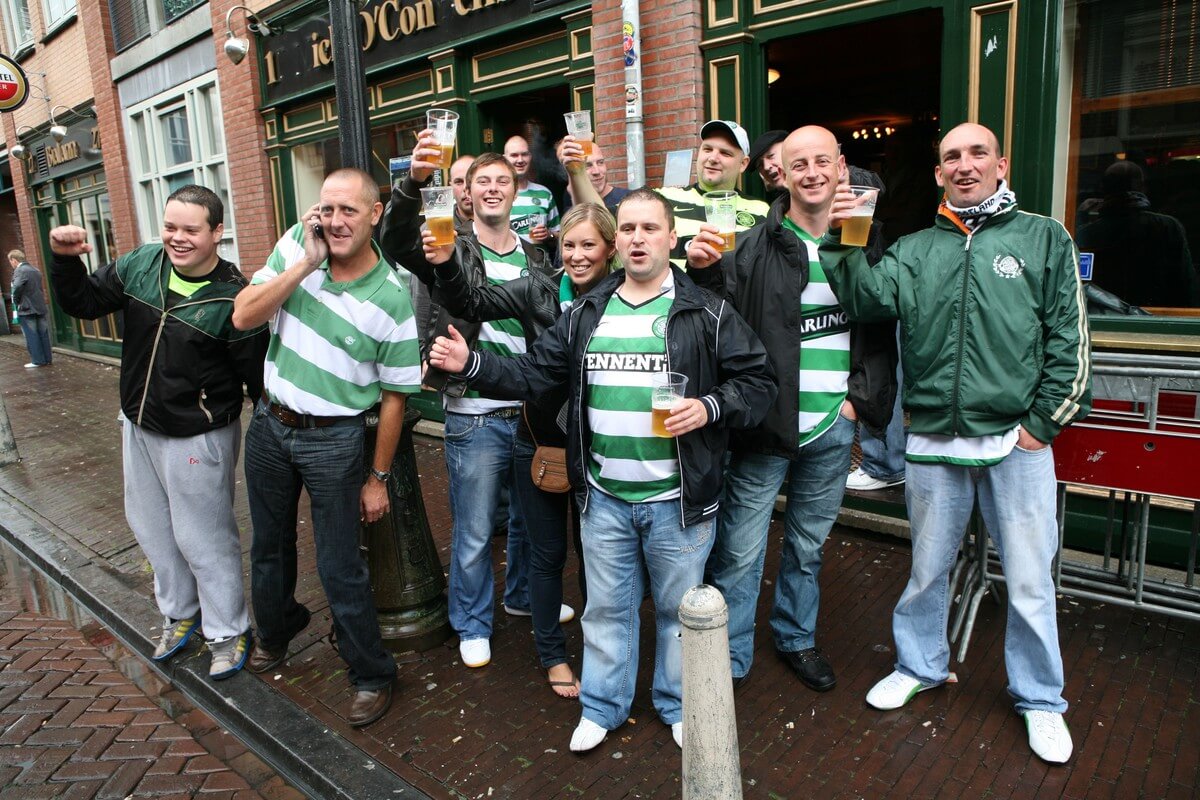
top-left (125, 72), bottom-right (238, 259)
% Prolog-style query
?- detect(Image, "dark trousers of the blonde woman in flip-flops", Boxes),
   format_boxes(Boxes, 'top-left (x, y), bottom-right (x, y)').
top-left (512, 435), bottom-right (577, 669)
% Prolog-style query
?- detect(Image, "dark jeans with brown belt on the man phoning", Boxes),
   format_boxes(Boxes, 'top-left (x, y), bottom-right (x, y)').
top-left (245, 401), bottom-right (396, 690)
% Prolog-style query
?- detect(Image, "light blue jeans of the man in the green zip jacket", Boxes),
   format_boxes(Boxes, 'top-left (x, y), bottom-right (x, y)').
top-left (892, 447), bottom-right (1067, 714)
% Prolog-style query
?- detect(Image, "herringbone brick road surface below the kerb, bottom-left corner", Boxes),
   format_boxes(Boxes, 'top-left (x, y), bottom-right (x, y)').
top-left (0, 581), bottom-right (301, 800)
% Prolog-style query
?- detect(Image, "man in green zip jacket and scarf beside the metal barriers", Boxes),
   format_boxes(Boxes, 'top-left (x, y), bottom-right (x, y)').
top-left (821, 122), bottom-right (1091, 763)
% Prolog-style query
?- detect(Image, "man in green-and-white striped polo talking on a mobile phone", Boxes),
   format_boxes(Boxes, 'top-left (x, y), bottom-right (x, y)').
top-left (234, 169), bottom-right (421, 727)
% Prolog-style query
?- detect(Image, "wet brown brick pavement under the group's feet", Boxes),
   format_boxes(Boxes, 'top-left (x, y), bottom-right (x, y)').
top-left (0, 337), bottom-right (1200, 800)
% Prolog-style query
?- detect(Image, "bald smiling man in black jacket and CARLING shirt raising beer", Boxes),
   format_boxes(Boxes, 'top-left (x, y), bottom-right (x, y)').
top-left (688, 126), bottom-right (895, 691)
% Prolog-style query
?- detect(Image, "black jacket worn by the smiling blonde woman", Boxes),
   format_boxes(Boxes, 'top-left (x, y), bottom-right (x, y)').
top-left (436, 252), bottom-right (566, 447)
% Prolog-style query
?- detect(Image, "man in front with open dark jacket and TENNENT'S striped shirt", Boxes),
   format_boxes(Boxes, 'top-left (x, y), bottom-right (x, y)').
top-left (430, 188), bottom-right (775, 752)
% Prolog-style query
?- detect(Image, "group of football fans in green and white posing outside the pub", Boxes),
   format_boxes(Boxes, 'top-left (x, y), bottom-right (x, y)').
top-left (37, 106), bottom-right (1090, 763)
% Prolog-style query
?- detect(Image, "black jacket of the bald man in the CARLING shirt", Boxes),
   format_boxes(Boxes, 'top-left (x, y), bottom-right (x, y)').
top-left (688, 189), bottom-right (896, 458)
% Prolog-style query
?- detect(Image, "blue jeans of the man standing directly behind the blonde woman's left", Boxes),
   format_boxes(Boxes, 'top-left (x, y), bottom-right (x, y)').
top-left (445, 411), bottom-right (529, 639)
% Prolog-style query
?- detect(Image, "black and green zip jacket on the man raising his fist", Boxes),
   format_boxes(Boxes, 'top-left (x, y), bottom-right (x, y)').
top-left (50, 245), bottom-right (270, 437)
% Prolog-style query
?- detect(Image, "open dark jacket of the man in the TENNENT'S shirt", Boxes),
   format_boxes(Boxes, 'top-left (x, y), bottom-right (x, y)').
top-left (453, 267), bottom-right (776, 525)
